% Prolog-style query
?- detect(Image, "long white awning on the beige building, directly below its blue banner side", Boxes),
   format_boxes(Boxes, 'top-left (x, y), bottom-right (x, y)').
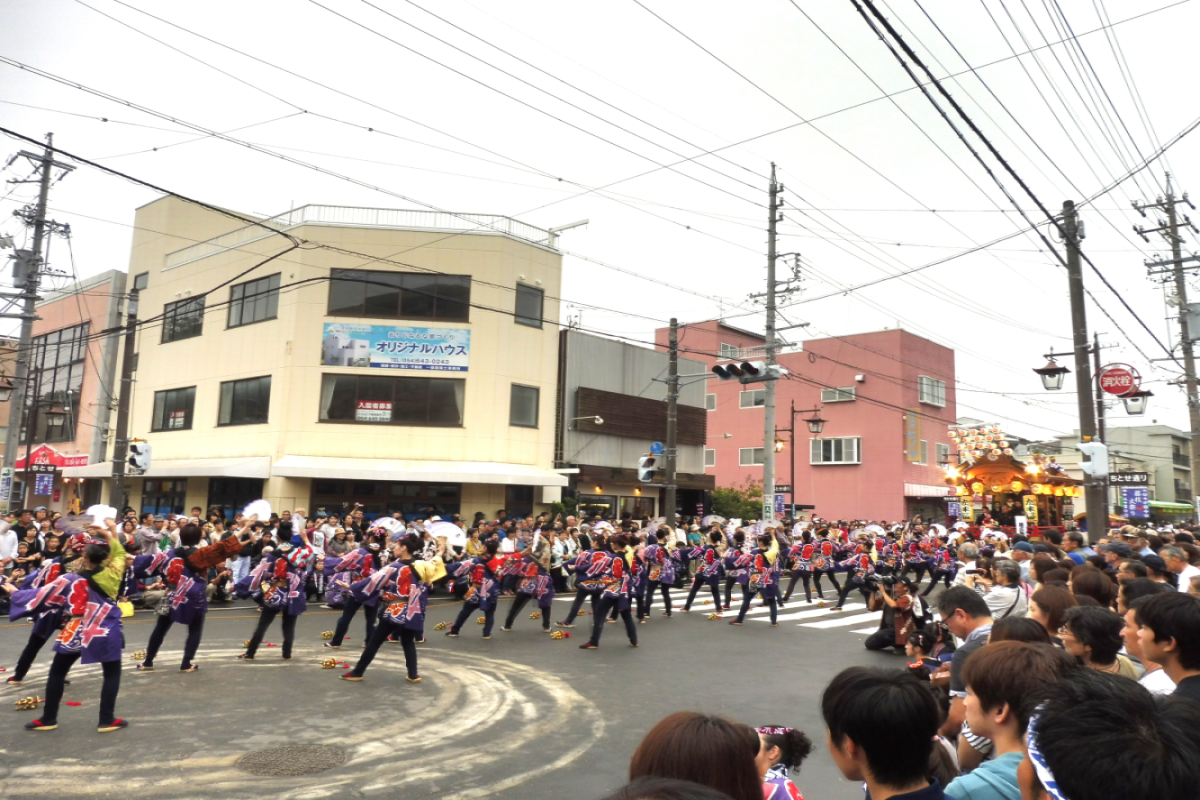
top-left (271, 456), bottom-right (568, 486)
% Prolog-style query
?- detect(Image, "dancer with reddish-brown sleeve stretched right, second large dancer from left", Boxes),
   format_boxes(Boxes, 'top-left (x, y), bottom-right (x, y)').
top-left (133, 523), bottom-right (245, 672)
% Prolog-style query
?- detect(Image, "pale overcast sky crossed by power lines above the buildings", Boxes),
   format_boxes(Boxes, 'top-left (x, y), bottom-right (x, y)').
top-left (0, 0), bottom-right (1200, 438)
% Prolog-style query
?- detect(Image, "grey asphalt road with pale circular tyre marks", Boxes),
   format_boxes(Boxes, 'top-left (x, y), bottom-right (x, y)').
top-left (0, 587), bottom-right (902, 800)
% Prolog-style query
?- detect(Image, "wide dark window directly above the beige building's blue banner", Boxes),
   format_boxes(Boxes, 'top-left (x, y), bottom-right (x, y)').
top-left (329, 270), bottom-right (470, 321)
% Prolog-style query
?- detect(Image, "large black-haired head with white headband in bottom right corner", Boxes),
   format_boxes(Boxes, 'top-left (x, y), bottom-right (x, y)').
top-left (1016, 669), bottom-right (1200, 800)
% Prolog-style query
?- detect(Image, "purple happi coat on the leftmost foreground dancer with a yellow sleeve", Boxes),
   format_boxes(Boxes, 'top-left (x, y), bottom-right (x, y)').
top-left (8, 575), bottom-right (124, 664)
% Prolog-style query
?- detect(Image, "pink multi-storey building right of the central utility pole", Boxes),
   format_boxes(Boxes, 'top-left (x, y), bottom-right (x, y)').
top-left (655, 320), bottom-right (955, 521)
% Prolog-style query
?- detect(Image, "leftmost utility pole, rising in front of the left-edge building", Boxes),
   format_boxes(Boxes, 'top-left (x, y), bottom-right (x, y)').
top-left (0, 133), bottom-right (74, 511)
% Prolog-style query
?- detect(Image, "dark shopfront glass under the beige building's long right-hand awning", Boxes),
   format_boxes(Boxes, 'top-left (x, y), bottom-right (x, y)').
top-left (308, 480), bottom-right (462, 521)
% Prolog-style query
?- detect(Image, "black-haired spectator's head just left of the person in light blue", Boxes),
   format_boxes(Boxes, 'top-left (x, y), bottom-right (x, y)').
top-left (821, 666), bottom-right (940, 793)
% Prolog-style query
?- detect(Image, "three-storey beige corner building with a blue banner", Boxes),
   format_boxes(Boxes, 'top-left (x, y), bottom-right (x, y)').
top-left (65, 197), bottom-right (566, 518)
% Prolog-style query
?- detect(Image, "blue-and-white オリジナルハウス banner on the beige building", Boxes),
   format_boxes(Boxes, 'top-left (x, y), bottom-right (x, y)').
top-left (322, 323), bottom-right (470, 372)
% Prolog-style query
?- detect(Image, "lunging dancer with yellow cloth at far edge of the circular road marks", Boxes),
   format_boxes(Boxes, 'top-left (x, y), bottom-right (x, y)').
top-left (342, 534), bottom-right (446, 684)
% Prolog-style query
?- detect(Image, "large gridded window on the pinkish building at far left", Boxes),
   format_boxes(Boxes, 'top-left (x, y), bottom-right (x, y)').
top-left (27, 323), bottom-right (88, 441)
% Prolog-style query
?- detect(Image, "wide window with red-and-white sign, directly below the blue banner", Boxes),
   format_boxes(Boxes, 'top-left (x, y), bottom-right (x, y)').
top-left (320, 374), bottom-right (467, 427)
